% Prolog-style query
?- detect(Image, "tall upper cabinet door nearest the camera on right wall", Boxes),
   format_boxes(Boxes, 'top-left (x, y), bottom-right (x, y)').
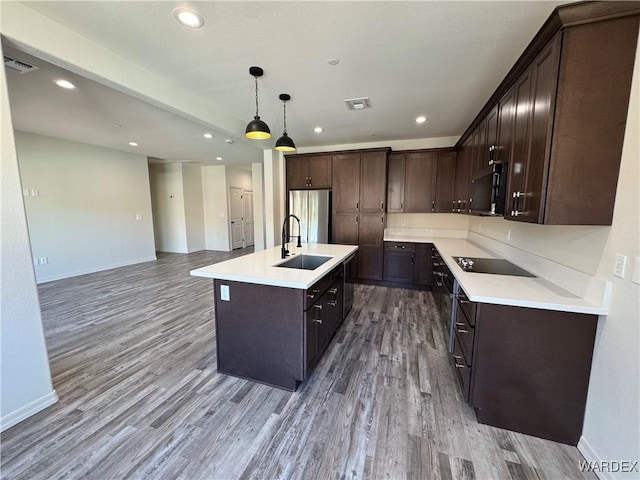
top-left (515, 35), bottom-right (561, 223)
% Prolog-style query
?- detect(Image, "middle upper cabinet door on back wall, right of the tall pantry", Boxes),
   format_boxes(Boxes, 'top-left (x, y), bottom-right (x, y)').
top-left (404, 152), bottom-right (438, 213)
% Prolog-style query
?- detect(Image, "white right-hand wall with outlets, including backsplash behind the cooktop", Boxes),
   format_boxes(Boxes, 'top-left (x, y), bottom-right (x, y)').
top-left (469, 35), bottom-right (640, 479)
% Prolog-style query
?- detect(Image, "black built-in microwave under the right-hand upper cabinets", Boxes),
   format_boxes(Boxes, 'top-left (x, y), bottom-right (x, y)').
top-left (469, 163), bottom-right (509, 216)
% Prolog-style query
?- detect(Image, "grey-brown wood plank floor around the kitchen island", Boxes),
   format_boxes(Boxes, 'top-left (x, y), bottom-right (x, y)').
top-left (1, 251), bottom-right (595, 480)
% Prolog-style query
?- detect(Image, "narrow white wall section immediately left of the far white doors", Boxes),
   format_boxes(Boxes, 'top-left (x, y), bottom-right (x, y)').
top-left (202, 165), bottom-right (231, 252)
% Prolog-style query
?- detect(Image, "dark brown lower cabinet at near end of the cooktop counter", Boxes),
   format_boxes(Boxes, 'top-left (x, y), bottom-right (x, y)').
top-left (452, 296), bottom-right (598, 445)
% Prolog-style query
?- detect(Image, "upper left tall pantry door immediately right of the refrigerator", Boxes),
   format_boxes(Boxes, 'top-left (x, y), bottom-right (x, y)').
top-left (331, 153), bottom-right (360, 212)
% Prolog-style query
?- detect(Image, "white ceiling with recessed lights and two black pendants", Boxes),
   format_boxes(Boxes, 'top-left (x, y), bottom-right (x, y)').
top-left (2, 1), bottom-right (565, 163)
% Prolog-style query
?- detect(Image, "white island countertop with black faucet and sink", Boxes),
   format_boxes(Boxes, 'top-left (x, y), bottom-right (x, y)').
top-left (190, 242), bottom-right (358, 290)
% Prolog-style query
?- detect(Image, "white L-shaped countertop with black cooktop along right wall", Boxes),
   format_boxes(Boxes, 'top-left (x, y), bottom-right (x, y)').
top-left (384, 229), bottom-right (609, 315)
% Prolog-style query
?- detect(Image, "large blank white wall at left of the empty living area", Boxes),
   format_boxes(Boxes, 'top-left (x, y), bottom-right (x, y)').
top-left (15, 132), bottom-right (156, 282)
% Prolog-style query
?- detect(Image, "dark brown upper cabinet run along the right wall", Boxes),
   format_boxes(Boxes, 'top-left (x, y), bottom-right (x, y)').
top-left (456, 2), bottom-right (640, 225)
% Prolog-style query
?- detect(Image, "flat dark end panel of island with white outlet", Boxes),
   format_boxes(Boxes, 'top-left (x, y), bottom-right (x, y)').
top-left (214, 279), bottom-right (306, 390)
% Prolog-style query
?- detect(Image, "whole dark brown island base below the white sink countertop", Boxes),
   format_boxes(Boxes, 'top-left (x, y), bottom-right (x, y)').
top-left (214, 265), bottom-right (344, 391)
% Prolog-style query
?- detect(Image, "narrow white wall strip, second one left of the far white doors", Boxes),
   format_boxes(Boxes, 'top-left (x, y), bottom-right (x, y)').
top-left (182, 164), bottom-right (205, 252)
